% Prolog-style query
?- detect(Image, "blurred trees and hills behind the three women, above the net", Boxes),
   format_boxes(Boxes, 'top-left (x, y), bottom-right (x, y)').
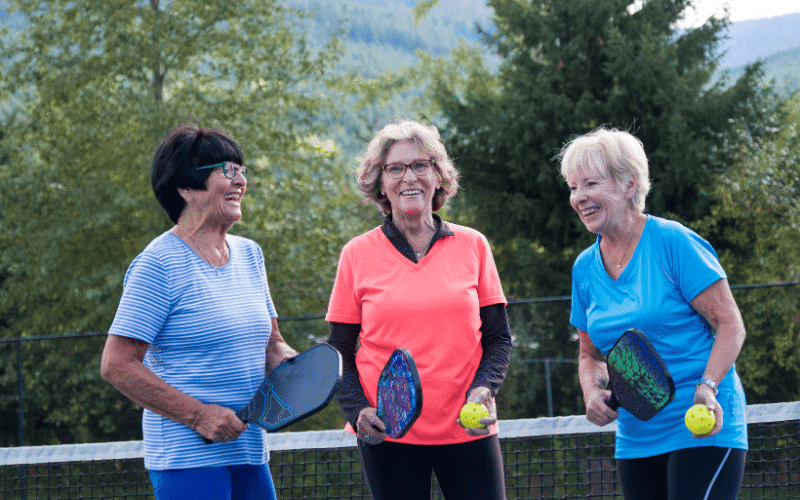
top-left (0, 0), bottom-right (800, 447)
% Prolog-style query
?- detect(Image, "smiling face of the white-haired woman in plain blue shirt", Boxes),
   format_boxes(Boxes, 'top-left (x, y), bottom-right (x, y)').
top-left (567, 165), bottom-right (636, 235)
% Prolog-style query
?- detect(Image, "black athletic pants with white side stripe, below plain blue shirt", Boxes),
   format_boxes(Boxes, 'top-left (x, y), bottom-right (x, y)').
top-left (617, 446), bottom-right (747, 500)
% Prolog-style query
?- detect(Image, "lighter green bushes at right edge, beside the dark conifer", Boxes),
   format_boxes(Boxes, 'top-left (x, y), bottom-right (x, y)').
top-left (693, 97), bottom-right (800, 403)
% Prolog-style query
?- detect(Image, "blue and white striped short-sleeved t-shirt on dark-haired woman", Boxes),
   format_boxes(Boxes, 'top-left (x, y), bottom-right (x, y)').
top-left (109, 232), bottom-right (277, 470)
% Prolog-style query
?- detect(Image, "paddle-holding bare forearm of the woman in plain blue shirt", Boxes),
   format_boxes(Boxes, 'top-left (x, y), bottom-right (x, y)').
top-left (578, 330), bottom-right (619, 426)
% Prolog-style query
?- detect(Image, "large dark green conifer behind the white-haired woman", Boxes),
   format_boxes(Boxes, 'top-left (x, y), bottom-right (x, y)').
top-left (428, 0), bottom-right (776, 295)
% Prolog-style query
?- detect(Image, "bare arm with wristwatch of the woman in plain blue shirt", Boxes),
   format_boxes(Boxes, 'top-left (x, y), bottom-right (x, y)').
top-left (689, 279), bottom-right (745, 437)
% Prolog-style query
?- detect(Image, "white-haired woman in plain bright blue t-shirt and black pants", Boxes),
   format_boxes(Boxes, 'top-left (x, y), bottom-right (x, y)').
top-left (559, 128), bottom-right (747, 500)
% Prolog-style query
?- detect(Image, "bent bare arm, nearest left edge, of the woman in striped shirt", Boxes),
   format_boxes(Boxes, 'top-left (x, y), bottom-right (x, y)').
top-left (100, 335), bottom-right (247, 442)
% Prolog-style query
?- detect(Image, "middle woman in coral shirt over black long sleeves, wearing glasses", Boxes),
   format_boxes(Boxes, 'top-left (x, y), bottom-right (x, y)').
top-left (326, 121), bottom-right (511, 500)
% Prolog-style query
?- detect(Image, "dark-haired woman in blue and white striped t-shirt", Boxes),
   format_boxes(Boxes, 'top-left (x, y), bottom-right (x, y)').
top-left (101, 125), bottom-right (297, 500)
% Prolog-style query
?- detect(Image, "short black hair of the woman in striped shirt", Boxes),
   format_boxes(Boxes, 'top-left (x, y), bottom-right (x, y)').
top-left (150, 123), bottom-right (244, 224)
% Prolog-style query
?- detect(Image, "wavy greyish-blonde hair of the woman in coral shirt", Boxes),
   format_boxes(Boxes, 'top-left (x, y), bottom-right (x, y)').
top-left (356, 120), bottom-right (459, 215)
